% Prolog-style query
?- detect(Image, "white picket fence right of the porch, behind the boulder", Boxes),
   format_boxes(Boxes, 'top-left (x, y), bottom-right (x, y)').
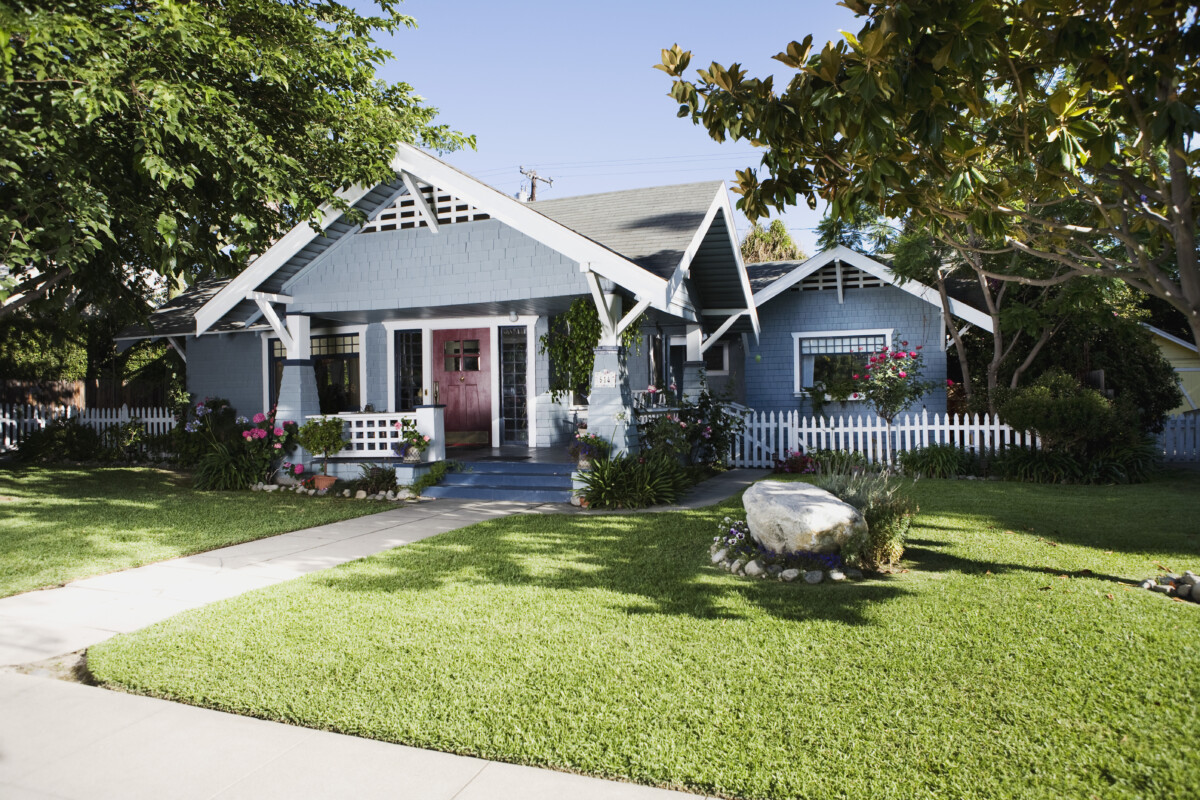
top-left (733, 409), bottom-right (1200, 468)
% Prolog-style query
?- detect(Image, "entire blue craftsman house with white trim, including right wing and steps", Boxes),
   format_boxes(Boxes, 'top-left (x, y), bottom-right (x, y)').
top-left (120, 145), bottom-right (988, 499)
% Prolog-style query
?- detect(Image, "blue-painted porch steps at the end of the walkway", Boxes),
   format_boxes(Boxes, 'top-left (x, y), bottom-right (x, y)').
top-left (425, 461), bottom-right (574, 503)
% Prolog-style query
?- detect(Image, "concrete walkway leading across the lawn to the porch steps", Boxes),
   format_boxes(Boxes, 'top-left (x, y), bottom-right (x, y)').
top-left (0, 500), bottom-right (559, 666)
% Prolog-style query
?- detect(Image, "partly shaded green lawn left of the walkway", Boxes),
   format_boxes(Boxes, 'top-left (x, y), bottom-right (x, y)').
top-left (0, 468), bottom-right (380, 597)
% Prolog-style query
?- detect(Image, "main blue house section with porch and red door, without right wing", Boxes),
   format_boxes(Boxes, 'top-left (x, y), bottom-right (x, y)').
top-left (120, 145), bottom-right (758, 470)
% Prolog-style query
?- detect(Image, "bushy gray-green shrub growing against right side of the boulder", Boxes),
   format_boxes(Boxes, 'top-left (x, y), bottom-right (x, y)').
top-left (814, 470), bottom-right (918, 571)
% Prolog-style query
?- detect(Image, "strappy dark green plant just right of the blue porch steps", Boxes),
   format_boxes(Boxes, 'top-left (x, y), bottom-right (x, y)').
top-left (580, 455), bottom-right (691, 509)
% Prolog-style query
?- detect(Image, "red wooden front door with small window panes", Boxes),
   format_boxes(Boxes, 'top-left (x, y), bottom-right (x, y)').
top-left (433, 327), bottom-right (492, 445)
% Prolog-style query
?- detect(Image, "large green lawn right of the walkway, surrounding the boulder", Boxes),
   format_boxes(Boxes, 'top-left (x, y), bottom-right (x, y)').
top-left (89, 475), bottom-right (1200, 800)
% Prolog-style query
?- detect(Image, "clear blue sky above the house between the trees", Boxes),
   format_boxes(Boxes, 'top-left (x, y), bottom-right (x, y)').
top-left (355, 0), bottom-right (859, 254)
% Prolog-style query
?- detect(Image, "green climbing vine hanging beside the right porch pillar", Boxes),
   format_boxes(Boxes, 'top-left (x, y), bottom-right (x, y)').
top-left (538, 297), bottom-right (642, 401)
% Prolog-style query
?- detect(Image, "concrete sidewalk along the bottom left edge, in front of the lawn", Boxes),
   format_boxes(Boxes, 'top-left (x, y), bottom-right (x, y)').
top-left (0, 672), bottom-right (700, 800)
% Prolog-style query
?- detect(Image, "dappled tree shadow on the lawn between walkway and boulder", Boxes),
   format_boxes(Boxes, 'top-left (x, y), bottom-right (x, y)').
top-left (317, 510), bottom-right (907, 625)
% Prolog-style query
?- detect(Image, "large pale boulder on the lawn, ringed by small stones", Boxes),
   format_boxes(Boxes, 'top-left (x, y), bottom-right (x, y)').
top-left (742, 481), bottom-right (866, 553)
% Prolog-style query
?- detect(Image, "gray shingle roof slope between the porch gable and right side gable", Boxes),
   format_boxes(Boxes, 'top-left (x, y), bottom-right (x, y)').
top-left (529, 181), bottom-right (725, 278)
